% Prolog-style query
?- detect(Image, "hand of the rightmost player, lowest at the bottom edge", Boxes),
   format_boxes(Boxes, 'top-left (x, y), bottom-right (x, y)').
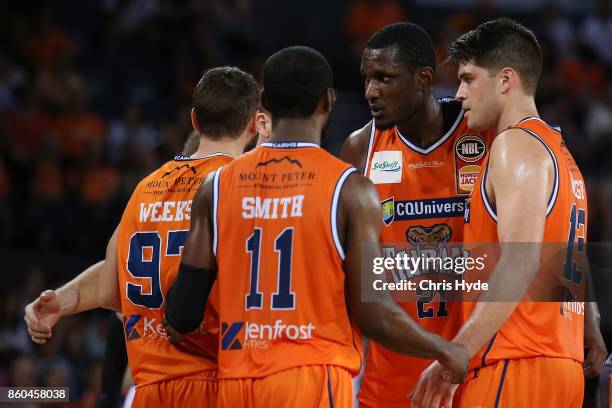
top-left (409, 361), bottom-right (459, 408)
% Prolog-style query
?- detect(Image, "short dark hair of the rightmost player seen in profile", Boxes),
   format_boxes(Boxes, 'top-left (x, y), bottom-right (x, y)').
top-left (448, 18), bottom-right (542, 95)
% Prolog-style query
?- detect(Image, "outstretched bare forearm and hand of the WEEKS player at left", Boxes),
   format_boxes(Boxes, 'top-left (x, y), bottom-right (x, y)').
top-left (24, 229), bottom-right (121, 344)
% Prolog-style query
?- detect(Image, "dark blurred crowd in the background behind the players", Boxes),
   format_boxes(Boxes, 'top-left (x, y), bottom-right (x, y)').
top-left (0, 0), bottom-right (612, 406)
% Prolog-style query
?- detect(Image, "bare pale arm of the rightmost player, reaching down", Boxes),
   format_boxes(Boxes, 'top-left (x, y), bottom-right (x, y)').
top-left (454, 129), bottom-right (554, 357)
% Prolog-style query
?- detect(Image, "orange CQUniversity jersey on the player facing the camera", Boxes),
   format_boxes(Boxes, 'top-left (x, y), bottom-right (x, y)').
top-left (359, 98), bottom-right (493, 406)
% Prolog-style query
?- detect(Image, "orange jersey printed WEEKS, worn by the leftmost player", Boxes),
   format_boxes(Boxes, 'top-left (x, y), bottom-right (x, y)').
top-left (117, 153), bottom-right (232, 385)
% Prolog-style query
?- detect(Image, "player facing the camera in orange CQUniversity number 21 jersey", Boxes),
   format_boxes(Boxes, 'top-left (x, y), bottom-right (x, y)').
top-left (340, 23), bottom-right (492, 407)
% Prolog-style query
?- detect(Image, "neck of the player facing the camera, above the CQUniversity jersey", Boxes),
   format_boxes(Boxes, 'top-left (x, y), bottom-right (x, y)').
top-left (397, 95), bottom-right (444, 148)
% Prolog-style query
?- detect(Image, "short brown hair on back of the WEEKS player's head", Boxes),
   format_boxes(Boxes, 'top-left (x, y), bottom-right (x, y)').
top-left (193, 67), bottom-right (260, 140)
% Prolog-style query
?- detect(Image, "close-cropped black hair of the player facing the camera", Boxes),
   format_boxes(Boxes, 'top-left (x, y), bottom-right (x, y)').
top-left (366, 23), bottom-right (436, 72)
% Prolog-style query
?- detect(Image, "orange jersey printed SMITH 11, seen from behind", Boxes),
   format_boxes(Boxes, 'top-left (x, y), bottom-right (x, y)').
top-left (213, 142), bottom-right (360, 379)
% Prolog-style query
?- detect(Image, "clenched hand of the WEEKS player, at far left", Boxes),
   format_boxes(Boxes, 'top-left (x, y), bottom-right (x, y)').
top-left (24, 290), bottom-right (62, 344)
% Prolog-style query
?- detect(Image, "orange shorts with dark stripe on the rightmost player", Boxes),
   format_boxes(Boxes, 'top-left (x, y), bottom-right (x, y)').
top-left (459, 357), bottom-right (584, 408)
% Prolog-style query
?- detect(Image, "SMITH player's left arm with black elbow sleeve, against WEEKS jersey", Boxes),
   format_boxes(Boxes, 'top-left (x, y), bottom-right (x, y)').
top-left (165, 173), bottom-right (217, 334)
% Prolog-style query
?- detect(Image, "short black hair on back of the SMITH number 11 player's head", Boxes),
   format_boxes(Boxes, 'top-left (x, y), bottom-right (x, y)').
top-left (263, 46), bottom-right (334, 121)
